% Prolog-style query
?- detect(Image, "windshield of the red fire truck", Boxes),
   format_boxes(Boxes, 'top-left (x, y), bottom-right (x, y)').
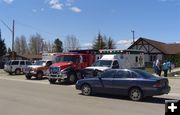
top-left (56, 55), bottom-right (80, 63)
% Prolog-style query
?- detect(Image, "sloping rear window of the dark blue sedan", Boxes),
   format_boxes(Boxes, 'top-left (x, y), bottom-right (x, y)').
top-left (134, 69), bottom-right (155, 79)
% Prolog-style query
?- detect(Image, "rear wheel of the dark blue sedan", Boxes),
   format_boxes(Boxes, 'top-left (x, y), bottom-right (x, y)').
top-left (129, 88), bottom-right (143, 101)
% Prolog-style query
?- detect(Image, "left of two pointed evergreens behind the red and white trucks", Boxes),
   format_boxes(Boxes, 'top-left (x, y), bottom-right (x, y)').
top-left (92, 32), bottom-right (107, 50)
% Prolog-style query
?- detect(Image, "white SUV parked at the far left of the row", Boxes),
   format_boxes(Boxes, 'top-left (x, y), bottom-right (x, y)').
top-left (4, 60), bottom-right (32, 75)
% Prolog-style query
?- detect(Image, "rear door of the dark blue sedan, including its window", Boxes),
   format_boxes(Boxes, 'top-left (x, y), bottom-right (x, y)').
top-left (112, 70), bottom-right (132, 95)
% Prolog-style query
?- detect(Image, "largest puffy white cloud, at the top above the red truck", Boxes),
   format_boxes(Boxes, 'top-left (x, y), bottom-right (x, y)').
top-left (49, 0), bottom-right (64, 10)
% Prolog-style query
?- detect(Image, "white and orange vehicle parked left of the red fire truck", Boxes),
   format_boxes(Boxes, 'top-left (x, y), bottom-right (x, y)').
top-left (24, 60), bottom-right (53, 79)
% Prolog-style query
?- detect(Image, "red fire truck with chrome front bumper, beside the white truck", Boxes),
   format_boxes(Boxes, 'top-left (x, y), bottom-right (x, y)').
top-left (48, 50), bottom-right (98, 84)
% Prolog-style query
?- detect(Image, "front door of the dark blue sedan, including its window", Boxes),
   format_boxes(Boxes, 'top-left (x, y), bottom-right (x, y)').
top-left (95, 70), bottom-right (116, 93)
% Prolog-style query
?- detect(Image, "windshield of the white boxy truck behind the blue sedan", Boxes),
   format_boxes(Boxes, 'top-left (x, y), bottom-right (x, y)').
top-left (93, 60), bottom-right (112, 67)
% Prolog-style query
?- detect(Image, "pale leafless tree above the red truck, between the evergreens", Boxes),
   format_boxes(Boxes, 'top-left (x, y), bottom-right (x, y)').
top-left (64, 35), bottom-right (80, 51)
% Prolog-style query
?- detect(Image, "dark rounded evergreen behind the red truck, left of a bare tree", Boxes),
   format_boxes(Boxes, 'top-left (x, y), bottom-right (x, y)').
top-left (53, 38), bottom-right (63, 52)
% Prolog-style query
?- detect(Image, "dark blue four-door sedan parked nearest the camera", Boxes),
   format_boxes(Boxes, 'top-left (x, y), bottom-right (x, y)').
top-left (76, 69), bottom-right (170, 101)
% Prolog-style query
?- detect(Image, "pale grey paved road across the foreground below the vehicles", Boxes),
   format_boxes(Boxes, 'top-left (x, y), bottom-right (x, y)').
top-left (0, 72), bottom-right (180, 115)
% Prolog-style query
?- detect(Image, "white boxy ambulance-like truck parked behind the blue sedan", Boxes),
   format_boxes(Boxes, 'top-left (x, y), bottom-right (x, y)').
top-left (84, 49), bottom-right (145, 73)
